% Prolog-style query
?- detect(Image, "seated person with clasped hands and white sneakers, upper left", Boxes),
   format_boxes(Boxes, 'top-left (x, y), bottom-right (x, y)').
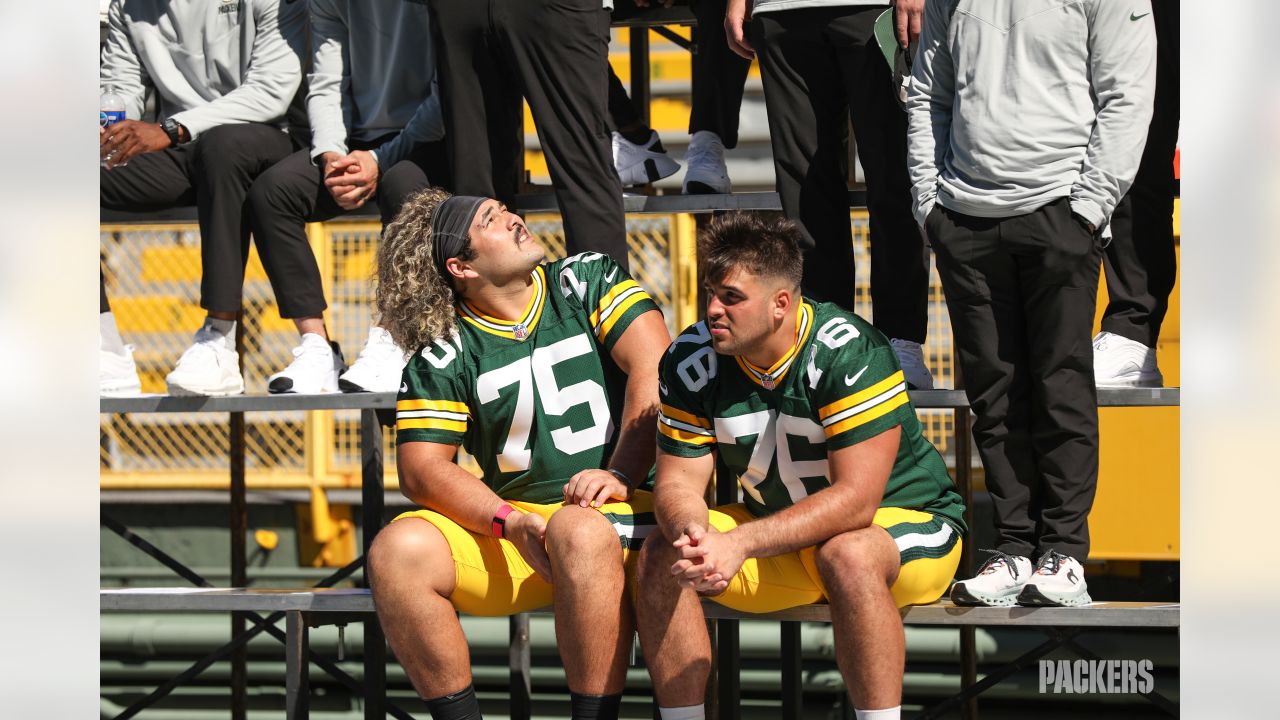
top-left (241, 0), bottom-right (447, 393)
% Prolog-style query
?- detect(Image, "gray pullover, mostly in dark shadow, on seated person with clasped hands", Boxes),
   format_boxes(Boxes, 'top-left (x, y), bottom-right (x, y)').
top-left (307, 0), bottom-right (444, 169)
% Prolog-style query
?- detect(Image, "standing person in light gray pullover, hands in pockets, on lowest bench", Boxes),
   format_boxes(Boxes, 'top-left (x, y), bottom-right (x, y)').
top-left (908, 0), bottom-right (1156, 605)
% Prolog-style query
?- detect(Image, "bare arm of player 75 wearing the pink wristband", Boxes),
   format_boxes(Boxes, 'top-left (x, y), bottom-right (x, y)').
top-left (396, 442), bottom-right (552, 580)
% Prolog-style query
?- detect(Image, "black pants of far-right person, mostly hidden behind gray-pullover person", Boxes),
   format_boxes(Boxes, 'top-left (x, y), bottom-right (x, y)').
top-left (1102, 1), bottom-right (1180, 347)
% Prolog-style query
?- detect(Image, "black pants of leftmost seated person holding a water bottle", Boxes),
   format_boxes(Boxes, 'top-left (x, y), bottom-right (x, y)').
top-left (99, 123), bottom-right (300, 313)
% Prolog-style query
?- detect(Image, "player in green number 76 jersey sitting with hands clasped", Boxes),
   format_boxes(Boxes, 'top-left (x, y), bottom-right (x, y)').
top-left (636, 213), bottom-right (965, 720)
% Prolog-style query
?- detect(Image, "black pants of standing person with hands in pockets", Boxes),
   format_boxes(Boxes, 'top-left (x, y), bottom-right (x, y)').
top-left (924, 199), bottom-right (1102, 561)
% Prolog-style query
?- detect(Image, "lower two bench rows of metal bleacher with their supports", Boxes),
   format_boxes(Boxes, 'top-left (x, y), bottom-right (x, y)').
top-left (100, 388), bottom-right (1180, 720)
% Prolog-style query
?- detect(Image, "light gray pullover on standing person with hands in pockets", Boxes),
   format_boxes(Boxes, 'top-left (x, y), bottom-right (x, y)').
top-left (906, 0), bottom-right (1156, 228)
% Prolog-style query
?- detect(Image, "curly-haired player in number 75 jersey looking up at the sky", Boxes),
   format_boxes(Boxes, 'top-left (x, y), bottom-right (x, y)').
top-left (367, 188), bottom-right (671, 720)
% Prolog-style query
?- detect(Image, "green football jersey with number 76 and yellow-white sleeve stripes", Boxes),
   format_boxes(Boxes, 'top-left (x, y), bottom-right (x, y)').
top-left (658, 300), bottom-right (965, 532)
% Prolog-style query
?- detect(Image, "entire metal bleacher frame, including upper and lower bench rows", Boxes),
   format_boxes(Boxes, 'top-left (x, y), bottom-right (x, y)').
top-left (100, 5), bottom-right (1180, 720)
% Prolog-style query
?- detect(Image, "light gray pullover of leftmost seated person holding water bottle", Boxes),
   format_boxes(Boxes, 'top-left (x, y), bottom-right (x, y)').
top-left (100, 0), bottom-right (306, 138)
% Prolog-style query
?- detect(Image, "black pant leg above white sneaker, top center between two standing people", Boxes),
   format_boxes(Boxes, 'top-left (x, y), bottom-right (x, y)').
top-left (689, 0), bottom-right (751, 149)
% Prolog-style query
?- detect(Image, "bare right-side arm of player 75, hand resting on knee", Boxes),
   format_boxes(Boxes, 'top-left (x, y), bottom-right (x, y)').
top-left (564, 310), bottom-right (671, 507)
